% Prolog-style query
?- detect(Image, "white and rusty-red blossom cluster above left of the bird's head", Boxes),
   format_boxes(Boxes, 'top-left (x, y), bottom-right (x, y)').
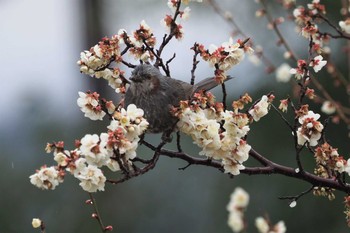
top-left (77, 20), bottom-right (156, 93)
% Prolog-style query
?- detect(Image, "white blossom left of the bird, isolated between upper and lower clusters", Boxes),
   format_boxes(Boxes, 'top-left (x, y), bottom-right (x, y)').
top-left (77, 91), bottom-right (106, 121)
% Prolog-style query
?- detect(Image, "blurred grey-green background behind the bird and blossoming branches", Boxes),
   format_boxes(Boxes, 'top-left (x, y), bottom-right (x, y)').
top-left (0, 0), bottom-right (349, 233)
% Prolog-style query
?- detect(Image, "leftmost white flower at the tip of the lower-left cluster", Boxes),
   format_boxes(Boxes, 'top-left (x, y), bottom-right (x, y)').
top-left (29, 167), bottom-right (63, 190)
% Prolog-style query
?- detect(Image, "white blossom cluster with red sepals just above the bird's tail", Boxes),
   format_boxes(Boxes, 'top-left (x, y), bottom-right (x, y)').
top-left (198, 38), bottom-right (253, 83)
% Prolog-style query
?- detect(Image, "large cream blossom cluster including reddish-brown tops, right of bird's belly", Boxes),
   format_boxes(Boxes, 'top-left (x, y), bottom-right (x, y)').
top-left (174, 92), bottom-right (267, 175)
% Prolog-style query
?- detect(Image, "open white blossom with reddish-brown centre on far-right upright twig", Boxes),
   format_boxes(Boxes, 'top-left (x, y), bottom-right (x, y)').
top-left (297, 111), bottom-right (323, 146)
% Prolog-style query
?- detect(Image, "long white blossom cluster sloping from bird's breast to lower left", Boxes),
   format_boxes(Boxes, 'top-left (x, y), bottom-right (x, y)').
top-left (30, 104), bottom-right (148, 192)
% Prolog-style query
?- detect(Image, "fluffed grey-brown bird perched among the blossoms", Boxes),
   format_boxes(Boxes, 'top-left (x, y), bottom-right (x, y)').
top-left (124, 64), bottom-right (231, 138)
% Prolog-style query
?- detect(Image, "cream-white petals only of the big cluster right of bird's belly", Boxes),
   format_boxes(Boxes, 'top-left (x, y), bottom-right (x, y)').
top-left (177, 107), bottom-right (251, 175)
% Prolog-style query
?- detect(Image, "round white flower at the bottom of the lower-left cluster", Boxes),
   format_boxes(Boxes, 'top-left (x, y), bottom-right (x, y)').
top-left (76, 165), bottom-right (106, 193)
